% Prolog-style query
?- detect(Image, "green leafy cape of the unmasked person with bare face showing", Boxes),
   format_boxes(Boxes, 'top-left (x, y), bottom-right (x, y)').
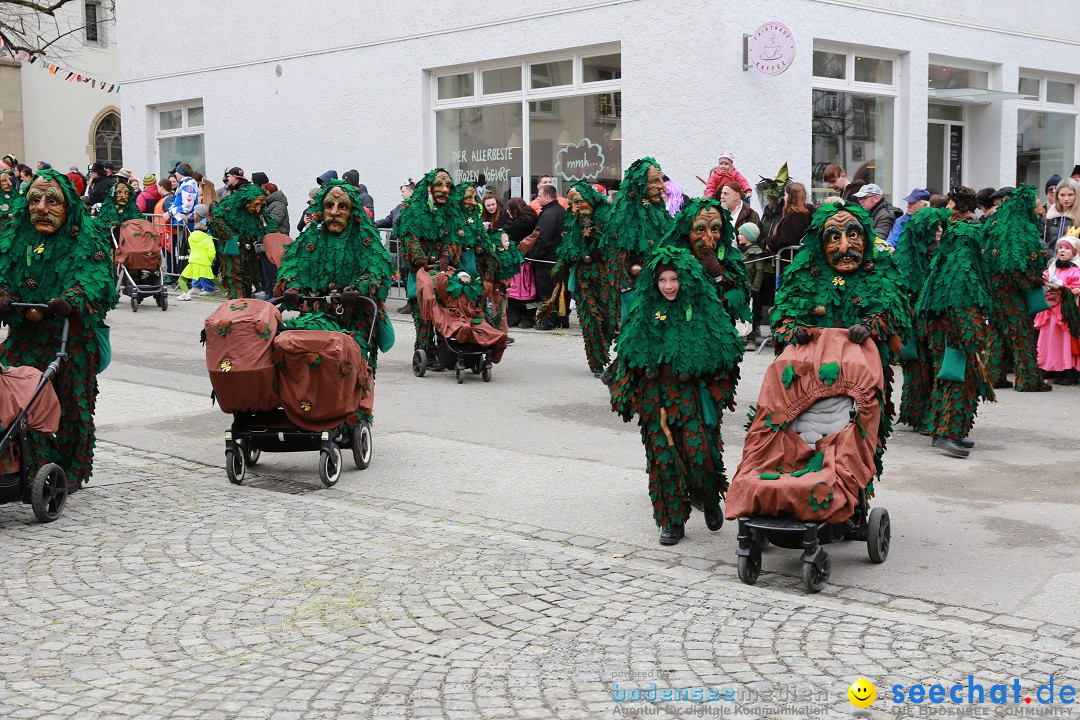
top-left (616, 246), bottom-right (745, 376)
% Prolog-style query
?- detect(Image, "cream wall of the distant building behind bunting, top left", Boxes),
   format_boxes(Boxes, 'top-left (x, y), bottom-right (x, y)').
top-left (19, 2), bottom-right (119, 171)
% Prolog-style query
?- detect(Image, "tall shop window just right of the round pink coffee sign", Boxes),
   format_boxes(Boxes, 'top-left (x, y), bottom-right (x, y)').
top-left (811, 46), bottom-right (896, 202)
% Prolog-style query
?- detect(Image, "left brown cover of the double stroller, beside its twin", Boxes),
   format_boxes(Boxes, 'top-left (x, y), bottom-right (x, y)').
top-left (203, 298), bottom-right (282, 412)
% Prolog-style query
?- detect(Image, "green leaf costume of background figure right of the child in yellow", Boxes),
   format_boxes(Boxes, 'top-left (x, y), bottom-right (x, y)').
top-left (207, 182), bottom-right (267, 299)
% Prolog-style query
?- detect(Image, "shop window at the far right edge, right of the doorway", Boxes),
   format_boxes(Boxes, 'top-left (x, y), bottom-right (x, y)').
top-left (1016, 74), bottom-right (1080, 188)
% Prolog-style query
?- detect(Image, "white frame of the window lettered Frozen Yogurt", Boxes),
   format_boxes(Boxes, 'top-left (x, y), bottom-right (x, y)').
top-left (424, 43), bottom-right (622, 200)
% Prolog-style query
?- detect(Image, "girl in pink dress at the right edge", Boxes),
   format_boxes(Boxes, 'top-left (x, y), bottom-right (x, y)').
top-left (1035, 234), bottom-right (1080, 385)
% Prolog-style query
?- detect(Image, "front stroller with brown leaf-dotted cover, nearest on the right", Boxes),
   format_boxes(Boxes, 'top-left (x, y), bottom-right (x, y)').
top-left (726, 328), bottom-right (891, 593)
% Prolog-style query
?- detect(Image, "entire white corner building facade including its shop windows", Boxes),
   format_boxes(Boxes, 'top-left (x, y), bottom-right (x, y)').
top-left (118, 0), bottom-right (1080, 216)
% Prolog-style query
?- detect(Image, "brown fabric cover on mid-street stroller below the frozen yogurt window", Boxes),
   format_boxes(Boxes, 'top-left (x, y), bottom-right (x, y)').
top-left (416, 272), bottom-right (507, 363)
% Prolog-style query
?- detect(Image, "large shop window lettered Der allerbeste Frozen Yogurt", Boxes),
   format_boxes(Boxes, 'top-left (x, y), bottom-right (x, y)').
top-left (432, 47), bottom-right (622, 200)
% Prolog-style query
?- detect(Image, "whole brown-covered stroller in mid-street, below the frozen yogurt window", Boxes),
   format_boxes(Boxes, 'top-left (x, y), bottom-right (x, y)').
top-left (413, 271), bottom-right (507, 384)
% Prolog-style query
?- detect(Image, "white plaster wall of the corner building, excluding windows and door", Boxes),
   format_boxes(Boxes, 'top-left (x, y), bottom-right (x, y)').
top-left (118, 0), bottom-right (1080, 215)
